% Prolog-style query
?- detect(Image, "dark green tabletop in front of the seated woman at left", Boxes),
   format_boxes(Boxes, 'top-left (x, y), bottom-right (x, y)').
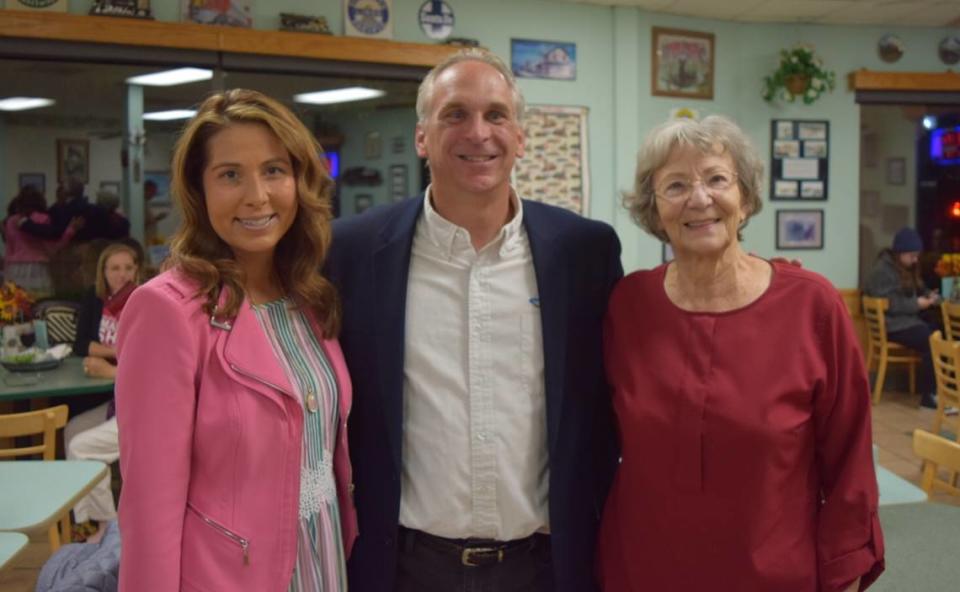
top-left (0, 356), bottom-right (113, 401)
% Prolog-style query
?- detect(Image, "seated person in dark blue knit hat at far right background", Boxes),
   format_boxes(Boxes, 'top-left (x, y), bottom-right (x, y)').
top-left (864, 227), bottom-right (940, 409)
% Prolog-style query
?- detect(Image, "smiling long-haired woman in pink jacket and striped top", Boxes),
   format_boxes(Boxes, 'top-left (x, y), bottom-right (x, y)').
top-left (116, 90), bottom-right (357, 592)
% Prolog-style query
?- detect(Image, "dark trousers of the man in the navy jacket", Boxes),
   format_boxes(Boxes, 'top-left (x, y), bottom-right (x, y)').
top-left (394, 528), bottom-right (554, 592)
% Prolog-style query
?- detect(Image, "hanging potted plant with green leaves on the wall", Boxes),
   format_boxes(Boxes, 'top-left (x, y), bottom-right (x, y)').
top-left (763, 45), bottom-right (836, 105)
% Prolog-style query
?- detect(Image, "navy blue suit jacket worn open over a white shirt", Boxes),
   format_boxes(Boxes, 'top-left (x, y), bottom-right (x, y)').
top-left (326, 196), bottom-right (623, 592)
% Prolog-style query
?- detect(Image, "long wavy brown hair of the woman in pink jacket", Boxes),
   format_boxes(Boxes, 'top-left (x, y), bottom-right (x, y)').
top-left (165, 89), bottom-right (340, 339)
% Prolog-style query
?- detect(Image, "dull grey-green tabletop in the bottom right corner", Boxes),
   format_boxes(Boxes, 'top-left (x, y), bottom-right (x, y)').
top-left (870, 503), bottom-right (960, 592)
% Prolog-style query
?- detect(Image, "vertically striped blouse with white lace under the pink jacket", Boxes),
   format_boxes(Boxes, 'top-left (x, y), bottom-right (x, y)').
top-left (254, 299), bottom-right (347, 592)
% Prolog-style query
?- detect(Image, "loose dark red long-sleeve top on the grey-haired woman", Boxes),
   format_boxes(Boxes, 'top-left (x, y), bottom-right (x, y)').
top-left (598, 264), bottom-right (884, 592)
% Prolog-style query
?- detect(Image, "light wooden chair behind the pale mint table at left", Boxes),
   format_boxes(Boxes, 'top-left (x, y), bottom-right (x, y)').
top-left (0, 405), bottom-right (70, 551)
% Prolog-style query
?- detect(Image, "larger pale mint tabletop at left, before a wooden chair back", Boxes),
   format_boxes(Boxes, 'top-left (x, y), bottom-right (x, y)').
top-left (0, 460), bottom-right (108, 532)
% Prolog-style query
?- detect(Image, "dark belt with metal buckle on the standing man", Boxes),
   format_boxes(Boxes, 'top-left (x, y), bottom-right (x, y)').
top-left (400, 526), bottom-right (550, 567)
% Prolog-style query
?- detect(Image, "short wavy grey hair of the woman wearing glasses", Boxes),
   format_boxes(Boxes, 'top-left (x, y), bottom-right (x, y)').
top-left (623, 115), bottom-right (763, 242)
